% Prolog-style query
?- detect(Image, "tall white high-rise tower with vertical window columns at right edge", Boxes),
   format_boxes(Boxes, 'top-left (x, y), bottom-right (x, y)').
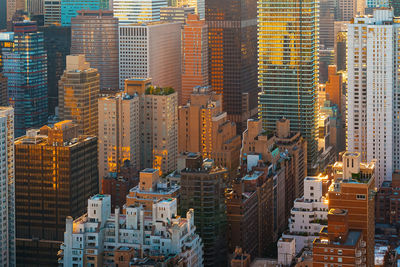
top-left (347, 9), bottom-right (400, 187)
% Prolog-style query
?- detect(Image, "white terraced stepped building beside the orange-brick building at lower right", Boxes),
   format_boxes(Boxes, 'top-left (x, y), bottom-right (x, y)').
top-left (278, 176), bottom-right (328, 254)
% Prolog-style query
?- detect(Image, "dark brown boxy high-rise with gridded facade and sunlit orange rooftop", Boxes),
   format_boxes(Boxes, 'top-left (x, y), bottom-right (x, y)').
top-left (15, 121), bottom-right (99, 266)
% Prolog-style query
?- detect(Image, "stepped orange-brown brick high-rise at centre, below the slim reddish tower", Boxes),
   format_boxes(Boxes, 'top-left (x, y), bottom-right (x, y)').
top-left (178, 87), bottom-right (241, 173)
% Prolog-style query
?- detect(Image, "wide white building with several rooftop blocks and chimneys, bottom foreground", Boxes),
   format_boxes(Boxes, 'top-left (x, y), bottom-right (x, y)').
top-left (59, 195), bottom-right (203, 267)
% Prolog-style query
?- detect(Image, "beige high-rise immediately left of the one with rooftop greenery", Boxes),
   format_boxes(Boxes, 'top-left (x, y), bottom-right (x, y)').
top-left (98, 93), bottom-right (140, 180)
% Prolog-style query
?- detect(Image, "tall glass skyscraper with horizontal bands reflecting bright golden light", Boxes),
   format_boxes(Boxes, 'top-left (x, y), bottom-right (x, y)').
top-left (258, 0), bottom-right (319, 174)
